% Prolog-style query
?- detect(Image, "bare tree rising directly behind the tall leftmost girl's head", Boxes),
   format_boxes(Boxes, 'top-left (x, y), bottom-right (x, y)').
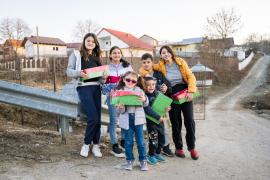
top-left (73, 19), bottom-right (101, 41)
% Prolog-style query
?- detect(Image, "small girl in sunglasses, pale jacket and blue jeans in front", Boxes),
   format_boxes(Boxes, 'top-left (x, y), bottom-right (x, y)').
top-left (116, 71), bottom-right (149, 171)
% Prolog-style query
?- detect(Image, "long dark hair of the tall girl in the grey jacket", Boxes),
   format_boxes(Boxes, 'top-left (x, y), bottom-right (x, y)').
top-left (80, 33), bottom-right (101, 61)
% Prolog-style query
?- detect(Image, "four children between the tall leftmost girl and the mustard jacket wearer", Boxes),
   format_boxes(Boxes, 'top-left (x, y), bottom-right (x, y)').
top-left (103, 47), bottom-right (176, 171)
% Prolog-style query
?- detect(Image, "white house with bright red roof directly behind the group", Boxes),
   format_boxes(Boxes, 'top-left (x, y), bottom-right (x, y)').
top-left (97, 28), bottom-right (154, 57)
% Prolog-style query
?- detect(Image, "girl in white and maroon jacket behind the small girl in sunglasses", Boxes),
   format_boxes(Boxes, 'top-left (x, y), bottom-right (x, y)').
top-left (102, 46), bottom-right (133, 157)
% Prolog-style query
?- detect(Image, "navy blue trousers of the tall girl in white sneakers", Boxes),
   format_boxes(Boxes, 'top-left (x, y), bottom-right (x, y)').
top-left (77, 85), bottom-right (101, 144)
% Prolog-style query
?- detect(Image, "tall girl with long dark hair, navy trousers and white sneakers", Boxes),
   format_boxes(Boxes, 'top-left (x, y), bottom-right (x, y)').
top-left (67, 33), bottom-right (102, 157)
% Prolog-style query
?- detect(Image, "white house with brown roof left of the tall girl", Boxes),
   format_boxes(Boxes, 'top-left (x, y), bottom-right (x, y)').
top-left (22, 36), bottom-right (67, 59)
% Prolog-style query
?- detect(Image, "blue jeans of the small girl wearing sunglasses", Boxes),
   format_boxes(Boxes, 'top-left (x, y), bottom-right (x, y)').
top-left (124, 113), bottom-right (146, 161)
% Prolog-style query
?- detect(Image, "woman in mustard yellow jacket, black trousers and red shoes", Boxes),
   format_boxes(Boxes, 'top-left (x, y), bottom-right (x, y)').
top-left (153, 46), bottom-right (199, 160)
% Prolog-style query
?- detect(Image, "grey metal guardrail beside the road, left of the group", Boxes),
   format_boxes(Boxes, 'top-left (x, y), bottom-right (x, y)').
top-left (0, 80), bottom-right (107, 144)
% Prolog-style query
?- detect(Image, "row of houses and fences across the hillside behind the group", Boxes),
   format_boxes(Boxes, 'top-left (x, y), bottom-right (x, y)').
top-left (0, 28), bottom-right (255, 85)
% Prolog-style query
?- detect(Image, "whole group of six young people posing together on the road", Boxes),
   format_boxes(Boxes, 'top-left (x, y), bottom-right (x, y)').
top-left (67, 33), bottom-right (199, 171)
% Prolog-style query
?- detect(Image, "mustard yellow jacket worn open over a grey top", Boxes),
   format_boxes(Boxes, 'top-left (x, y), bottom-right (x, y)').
top-left (153, 57), bottom-right (197, 93)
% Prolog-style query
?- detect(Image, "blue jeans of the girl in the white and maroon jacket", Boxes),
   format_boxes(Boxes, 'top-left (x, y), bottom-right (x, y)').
top-left (106, 96), bottom-right (125, 144)
